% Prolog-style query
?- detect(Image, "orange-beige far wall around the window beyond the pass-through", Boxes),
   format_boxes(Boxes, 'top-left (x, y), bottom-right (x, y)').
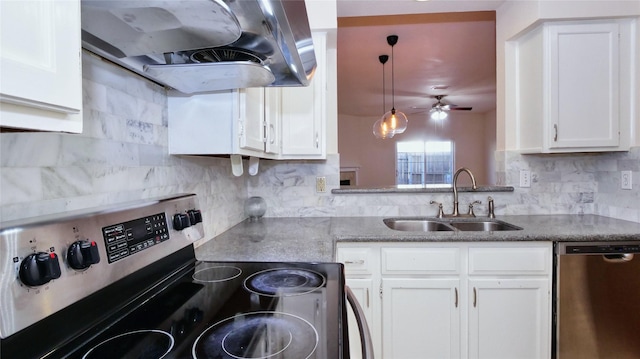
top-left (338, 111), bottom-right (496, 187)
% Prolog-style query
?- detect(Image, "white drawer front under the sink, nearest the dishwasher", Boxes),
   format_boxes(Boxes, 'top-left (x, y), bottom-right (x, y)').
top-left (469, 245), bottom-right (552, 275)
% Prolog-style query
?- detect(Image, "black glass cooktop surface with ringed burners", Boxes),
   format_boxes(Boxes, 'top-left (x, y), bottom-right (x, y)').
top-left (64, 262), bottom-right (348, 359)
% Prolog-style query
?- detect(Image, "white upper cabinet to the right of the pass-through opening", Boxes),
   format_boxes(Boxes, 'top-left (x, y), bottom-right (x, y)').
top-left (516, 19), bottom-right (634, 153)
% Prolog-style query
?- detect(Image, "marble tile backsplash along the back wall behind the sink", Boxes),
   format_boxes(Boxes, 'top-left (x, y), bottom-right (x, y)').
top-left (248, 147), bottom-right (640, 222)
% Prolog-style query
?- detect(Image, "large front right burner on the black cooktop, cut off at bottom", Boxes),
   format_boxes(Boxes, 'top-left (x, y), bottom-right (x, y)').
top-left (192, 311), bottom-right (318, 359)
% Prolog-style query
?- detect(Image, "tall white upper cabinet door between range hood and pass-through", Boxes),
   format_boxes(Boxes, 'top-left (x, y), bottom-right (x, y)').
top-left (281, 33), bottom-right (327, 158)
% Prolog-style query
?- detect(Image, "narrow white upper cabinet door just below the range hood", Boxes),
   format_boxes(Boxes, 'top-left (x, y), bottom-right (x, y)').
top-left (238, 88), bottom-right (265, 151)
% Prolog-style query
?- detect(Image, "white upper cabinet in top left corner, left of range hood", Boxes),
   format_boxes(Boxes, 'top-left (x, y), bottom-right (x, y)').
top-left (0, 0), bottom-right (82, 133)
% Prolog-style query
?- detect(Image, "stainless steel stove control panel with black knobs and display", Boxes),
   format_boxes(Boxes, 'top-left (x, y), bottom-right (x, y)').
top-left (0, 194), bottom-right (204, 338)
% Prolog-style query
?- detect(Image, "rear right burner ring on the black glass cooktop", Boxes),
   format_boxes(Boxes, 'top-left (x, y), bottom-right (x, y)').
top-left (244, 268), bottom-right (326, 297)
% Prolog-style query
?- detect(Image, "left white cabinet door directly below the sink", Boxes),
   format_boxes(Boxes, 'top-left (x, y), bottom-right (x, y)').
top-left (382, 278), bottom-right (460, 359)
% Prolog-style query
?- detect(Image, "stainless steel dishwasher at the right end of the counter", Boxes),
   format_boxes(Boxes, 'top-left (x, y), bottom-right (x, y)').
top-left (553, 241), bottom-right (640, 359)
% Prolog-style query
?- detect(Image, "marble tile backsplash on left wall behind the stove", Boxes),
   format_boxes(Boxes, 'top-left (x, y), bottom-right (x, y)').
top-left (0, 53), bottom-right (247, 245)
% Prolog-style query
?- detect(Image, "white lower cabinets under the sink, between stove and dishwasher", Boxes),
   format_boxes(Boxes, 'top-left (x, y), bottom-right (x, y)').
top-left (337, 242), bottom-right (552, 359)
